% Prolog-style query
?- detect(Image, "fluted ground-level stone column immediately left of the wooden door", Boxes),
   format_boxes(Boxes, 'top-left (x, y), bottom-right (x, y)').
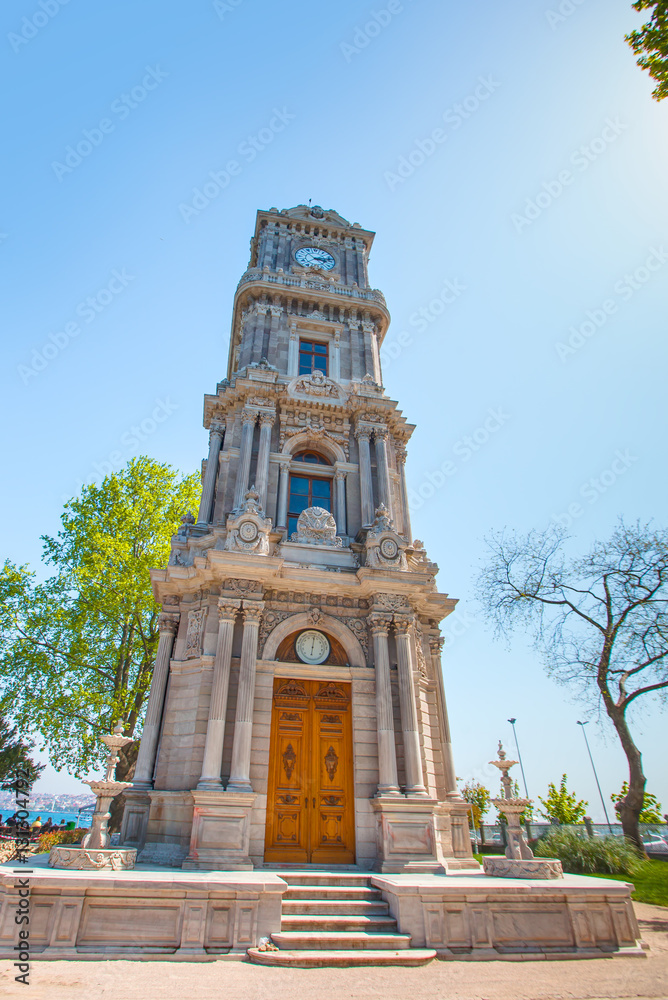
top-left (227, 601), bottom-right (264, 792)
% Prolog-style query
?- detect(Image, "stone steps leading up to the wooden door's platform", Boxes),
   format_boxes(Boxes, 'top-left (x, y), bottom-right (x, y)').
top-left (248, 871), bottom-right (436, 969)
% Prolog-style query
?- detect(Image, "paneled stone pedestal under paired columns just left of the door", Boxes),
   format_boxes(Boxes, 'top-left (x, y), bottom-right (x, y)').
top-left (182, 788), bottom-right (256, 871)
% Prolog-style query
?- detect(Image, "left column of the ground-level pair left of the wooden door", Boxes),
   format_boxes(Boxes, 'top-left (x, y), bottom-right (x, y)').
top-left (197, 598), bottom-right (241, 789)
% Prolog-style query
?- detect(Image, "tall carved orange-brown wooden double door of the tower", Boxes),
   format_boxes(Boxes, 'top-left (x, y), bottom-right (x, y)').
top-left (264, 679), bottom-right (355, 865)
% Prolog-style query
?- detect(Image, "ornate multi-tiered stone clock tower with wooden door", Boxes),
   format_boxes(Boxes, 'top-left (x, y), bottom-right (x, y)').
top-left (122, 205), bottom-right (475, 872)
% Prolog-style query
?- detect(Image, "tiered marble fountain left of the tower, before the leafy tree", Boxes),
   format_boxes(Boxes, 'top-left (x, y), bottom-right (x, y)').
top-left (49, 722), bottom-right (137, 871)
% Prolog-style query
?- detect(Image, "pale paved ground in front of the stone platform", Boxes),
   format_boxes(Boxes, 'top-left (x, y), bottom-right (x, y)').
top-left (0, 903), bottom-right (668, 1000)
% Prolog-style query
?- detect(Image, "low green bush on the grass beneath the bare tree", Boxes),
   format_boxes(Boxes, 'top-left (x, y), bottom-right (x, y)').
top-left (536, 830), bottom-right (643, 875)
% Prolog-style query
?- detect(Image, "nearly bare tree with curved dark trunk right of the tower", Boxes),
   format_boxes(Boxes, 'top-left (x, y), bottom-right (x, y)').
top-left (479, 519), bottom-right (668, 851)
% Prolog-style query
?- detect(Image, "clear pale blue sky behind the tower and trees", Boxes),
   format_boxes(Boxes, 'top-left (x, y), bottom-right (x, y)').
top-left (0, 0), bottom-right (668, 818)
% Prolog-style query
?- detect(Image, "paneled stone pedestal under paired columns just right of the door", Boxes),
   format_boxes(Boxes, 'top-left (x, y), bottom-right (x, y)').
top-left (371, 795), bottom-right (445, 875)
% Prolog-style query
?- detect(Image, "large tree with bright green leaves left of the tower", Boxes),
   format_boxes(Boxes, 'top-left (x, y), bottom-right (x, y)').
top-left (0, 457), bottom-right (200, 779)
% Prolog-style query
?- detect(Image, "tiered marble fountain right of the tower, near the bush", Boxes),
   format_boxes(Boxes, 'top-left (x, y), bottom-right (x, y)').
top-left (482, 740), bottom-right (564, 878)
